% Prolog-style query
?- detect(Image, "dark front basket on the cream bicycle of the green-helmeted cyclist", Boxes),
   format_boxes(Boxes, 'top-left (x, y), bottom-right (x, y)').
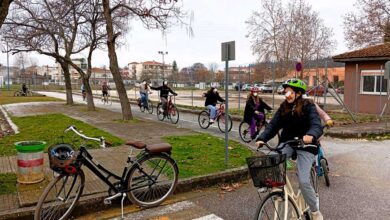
top-left (246, 154), bottom-right (286, 188)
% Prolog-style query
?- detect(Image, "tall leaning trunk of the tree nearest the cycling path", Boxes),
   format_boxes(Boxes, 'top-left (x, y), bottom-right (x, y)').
top-left (103, 0), bottom-right (133, 120)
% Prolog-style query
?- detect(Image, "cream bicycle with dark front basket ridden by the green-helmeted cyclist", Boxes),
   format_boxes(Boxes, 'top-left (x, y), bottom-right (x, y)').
top-left (246, 140), bottom-right (319, 220)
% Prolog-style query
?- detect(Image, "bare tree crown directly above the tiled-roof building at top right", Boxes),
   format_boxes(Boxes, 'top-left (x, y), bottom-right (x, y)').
top-left (344, 0), bottom-right (390, 48)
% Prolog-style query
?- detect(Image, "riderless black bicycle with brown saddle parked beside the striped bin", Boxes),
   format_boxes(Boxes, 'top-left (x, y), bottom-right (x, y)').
top-left (34, 126), bottom-right (178, 220)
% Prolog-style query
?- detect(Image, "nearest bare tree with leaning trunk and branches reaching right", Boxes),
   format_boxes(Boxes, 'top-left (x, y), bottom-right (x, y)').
top-left (102, 0), bottom-right (187, 120)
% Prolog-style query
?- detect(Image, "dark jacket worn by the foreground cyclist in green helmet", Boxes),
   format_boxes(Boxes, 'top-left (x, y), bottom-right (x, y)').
top-left (257, 99), bottom-right (323, 154)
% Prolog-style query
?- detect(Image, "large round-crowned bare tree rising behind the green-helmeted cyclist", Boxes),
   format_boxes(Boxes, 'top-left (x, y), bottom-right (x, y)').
top-left (246, 0), bottom-right (334, 77)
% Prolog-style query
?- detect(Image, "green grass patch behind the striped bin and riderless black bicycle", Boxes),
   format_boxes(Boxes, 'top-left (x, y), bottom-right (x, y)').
top-left (0, 114), bottom-right (123, 156)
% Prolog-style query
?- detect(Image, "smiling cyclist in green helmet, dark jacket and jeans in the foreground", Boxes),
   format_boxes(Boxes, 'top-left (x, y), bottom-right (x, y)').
top-left (256, 79), bottom-right (323, 220)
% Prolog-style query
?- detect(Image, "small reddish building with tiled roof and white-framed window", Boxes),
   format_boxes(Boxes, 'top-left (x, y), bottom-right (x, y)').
top-left (333, 43), bottom-right (390, 114)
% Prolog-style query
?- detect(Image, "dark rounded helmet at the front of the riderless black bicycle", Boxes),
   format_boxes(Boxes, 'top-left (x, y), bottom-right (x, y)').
top-left (48, 144), bottom-right (79, 174)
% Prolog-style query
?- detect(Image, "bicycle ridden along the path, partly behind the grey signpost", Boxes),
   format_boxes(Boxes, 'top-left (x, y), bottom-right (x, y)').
top-left (198, 103), bottom-right (233, 133)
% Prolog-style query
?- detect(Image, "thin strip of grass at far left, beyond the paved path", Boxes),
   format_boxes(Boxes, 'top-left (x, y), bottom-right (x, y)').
top-left (0, 90), bottom-right (63, 105)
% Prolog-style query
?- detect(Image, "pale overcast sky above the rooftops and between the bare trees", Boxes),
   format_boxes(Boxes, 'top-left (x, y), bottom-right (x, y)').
top-left (0, 0), bottom-right (356, 68)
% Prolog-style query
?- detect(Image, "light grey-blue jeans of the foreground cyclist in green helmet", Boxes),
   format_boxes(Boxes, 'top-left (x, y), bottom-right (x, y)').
top-left (282, 146), bottom-right (319, 212)
